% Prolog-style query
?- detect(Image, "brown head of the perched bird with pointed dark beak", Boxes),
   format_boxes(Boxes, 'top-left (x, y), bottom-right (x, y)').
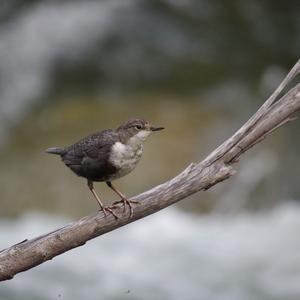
top-left (117, 119), bottom-right (164, 143)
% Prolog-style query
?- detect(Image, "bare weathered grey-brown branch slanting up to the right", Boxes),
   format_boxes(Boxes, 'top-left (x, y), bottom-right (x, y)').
top-left (0, 60), bottom-right (300, 281)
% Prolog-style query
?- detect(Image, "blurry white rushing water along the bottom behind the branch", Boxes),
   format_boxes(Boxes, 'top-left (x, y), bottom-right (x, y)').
top-left (0, 204), bottom-right (300, 300)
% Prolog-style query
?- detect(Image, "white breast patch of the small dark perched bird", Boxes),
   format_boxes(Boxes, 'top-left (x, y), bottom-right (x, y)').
top-left (109, 142), bottom-right (143, 178)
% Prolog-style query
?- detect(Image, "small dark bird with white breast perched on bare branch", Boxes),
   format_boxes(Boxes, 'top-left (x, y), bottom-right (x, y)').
top-left (46, 119), bottom-right (164, 218)
